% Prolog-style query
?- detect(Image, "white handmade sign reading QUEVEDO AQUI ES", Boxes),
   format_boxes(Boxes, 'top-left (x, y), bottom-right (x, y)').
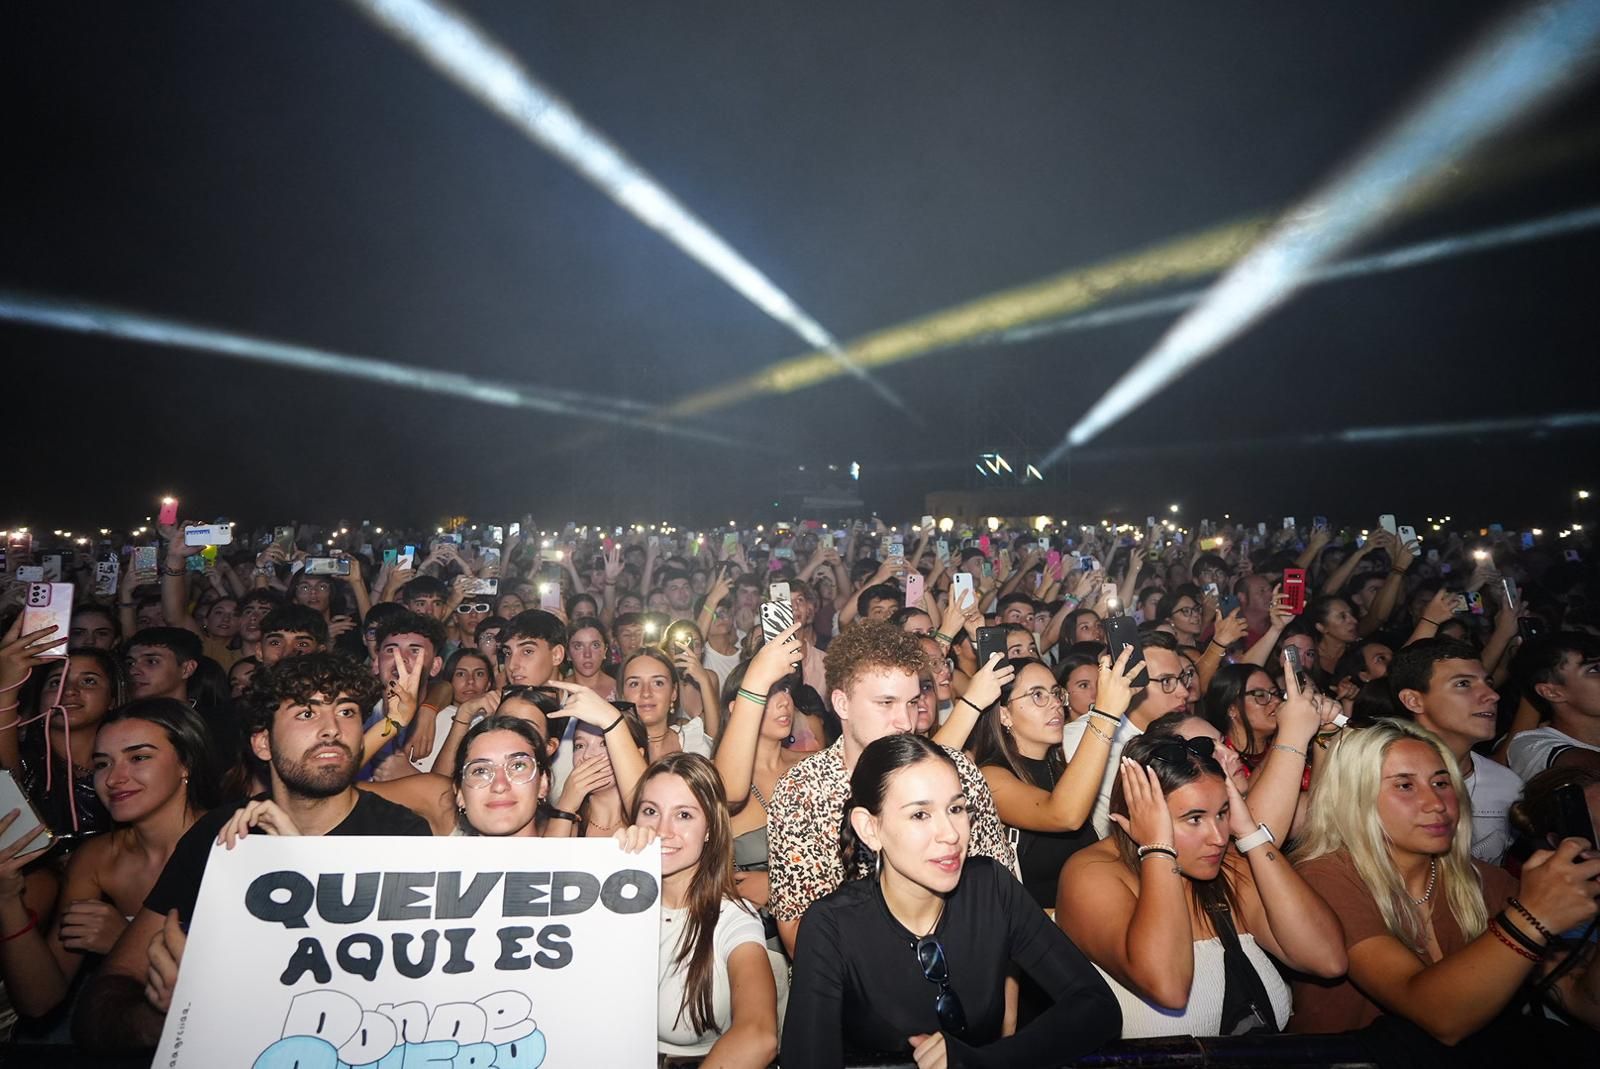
top-left (152, 835), bottom-right (661, 1069)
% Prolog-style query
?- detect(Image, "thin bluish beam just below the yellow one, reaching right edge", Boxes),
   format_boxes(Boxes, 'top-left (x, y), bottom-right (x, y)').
top-left (973, 205), bottom-right (1600, 346)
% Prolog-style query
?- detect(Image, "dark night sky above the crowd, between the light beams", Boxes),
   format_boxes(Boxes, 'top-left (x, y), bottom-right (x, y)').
top-left (0, 0), bottom-right (1600, 526)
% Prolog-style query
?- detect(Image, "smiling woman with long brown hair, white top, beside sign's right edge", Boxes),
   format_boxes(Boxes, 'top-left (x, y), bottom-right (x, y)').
top-left (618, 754), bottom-right (778, 1069)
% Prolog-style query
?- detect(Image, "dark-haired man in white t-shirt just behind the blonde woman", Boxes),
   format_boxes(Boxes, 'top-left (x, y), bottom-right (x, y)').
top-left (1389, 639), bottom-right (1522, 864)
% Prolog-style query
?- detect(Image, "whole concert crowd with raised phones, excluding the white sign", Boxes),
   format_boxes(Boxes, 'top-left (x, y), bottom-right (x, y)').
top-left (0, 512), bottom-right (1600, 1069)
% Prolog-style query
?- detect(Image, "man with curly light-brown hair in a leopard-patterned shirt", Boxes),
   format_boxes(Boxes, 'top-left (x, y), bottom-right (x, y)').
top-left (766, 619), bottom-right (1016, 954)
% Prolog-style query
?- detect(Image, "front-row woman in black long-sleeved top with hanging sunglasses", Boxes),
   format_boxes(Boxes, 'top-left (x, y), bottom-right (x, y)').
top-left (781, 735), bottom-right (1120, 1069)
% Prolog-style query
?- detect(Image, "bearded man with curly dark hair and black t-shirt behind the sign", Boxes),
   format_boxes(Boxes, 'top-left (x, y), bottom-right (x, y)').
top-left (72, 653), bottom-right (429, 1053)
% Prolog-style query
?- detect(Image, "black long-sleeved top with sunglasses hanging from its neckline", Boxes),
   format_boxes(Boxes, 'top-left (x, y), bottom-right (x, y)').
top-left (779, 858), bottom-right (1122, 1069)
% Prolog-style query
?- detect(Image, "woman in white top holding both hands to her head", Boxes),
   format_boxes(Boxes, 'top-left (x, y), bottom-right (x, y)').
top-left (1056, 733), bottom-right (1346, 1039)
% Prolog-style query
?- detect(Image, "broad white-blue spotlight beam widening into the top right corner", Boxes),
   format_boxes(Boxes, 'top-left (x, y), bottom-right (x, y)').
top-left (1045, 0), bottom-right (1600, 466)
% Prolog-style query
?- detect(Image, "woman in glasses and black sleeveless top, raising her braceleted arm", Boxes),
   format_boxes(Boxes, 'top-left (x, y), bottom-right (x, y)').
top-left (973, 651), bottom-right (1139, 909)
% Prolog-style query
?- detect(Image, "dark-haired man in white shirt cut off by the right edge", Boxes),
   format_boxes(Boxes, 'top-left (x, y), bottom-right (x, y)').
top-left (1506, 631), bottom-right (1600, 779)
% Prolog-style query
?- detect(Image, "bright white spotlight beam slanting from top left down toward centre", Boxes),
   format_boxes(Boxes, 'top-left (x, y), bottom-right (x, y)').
top-left (350, 0), bottom-right (912, 414)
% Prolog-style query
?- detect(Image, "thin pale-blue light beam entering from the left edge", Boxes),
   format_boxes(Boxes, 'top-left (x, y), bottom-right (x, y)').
top-left (0, 290), bottom-right (747, 448)
